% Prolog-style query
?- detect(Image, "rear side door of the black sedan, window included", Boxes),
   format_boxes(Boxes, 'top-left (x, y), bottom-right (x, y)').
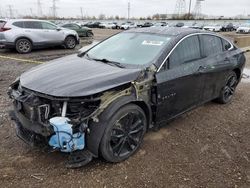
top-left (197, 34), bottom-right (234, 102)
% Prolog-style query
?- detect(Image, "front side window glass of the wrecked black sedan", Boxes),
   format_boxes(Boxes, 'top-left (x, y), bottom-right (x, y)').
top-left (168, 36), bottom-right (201, 69)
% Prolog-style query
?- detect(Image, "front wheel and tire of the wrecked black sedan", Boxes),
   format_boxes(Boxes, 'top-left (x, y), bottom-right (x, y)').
top-left (100, 104), bottom-right (147, 163)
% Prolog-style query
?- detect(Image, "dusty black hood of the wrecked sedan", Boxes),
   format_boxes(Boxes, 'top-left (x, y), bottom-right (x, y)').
top-left (20, 55), bottom-right (141, 97)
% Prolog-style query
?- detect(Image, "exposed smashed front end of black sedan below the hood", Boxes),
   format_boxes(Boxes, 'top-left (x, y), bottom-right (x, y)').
top-left (8, 81), bottom-right (103, 168)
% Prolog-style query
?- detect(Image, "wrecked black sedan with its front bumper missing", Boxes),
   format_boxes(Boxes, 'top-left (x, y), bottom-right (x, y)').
top-left (8, 27), bottom-right (245, 167)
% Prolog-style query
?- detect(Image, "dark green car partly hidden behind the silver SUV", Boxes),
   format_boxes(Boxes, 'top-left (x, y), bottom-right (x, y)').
top-left (60, 23), bottom-right (94, 37)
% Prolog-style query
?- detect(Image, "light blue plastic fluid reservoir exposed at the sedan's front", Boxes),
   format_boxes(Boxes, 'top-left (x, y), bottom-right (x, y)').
top-left (49, 117), bottom-right (85, 153)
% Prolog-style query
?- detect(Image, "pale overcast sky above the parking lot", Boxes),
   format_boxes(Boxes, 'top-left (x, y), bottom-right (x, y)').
top-left (0, 0), bottom-right (250, 17)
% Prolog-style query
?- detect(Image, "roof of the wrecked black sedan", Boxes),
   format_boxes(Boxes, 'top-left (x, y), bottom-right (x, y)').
top-left (125, 27), bottom-right (211, 36)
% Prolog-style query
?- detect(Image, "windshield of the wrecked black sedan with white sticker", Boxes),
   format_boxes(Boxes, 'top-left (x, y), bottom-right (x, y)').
top-left (87, 33), bottom-right (171, 65)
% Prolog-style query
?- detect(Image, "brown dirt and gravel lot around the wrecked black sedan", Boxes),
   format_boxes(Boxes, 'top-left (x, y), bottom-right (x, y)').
top-left (0, 30), bottom-right (250, 188)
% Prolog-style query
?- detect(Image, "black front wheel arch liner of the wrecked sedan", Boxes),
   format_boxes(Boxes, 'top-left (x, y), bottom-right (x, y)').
top-left (86, 95), bottom-right (152, 157)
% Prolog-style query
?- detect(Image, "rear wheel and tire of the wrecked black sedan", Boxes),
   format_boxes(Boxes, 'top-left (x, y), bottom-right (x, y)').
top-left (216, 71), bottom-right (238, 104)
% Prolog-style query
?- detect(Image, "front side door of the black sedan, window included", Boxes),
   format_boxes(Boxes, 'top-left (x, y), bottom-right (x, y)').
top-left (156, 35), bottom-right (204, 121)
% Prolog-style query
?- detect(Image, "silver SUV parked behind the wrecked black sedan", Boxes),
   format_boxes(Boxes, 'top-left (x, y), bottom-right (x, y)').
top-left (0, 19), bottom-right (80, 53)
